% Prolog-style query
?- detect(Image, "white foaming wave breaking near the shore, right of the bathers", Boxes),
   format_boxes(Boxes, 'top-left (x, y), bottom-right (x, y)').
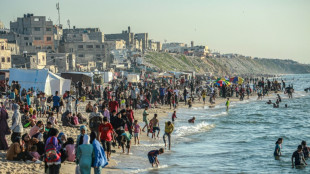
top-left (175, 121), bottom-right (215, 137)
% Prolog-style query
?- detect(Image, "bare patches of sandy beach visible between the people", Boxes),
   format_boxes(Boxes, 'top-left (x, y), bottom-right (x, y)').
top-left (0, 94), bottom-right (245, 174)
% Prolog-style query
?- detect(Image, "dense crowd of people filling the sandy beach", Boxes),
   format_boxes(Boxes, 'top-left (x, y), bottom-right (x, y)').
top-left (0, 75), bottom-right (302, 174)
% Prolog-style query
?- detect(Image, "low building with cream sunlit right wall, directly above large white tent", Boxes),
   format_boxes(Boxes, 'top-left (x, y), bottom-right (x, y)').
top-left (12, 52), bottom-right (46, 69)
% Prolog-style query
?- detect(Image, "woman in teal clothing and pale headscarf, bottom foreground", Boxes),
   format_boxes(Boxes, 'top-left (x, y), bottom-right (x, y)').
top-left (76, 135), bottom-right (94, 174)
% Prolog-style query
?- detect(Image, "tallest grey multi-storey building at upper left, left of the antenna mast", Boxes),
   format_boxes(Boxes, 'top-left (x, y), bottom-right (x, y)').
top-left (10, 14), bottom-right (55, 53)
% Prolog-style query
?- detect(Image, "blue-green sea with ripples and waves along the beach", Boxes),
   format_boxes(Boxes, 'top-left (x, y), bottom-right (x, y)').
top-left (112, 74), bottom-right (310, 174)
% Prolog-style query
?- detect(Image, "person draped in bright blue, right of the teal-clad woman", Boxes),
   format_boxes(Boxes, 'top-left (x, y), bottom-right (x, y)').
top-left (90, 132), bottom-right (108, 174)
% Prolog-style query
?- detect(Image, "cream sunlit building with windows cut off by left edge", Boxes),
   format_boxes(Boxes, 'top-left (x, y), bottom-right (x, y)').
top-left (0, 39), bottom-right (11, 69)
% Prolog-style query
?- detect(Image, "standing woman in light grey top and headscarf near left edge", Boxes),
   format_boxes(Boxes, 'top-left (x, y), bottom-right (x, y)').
top-left (10, 104), bottom-right (24, 142)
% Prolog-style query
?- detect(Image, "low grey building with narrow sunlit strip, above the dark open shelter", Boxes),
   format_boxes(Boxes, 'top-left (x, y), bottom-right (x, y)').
top-left (46, 53), bottom-right (76, 73)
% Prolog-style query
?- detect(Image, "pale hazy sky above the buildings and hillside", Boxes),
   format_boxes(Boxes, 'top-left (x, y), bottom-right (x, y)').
top-left (0, 0), bottom-right (310, 64)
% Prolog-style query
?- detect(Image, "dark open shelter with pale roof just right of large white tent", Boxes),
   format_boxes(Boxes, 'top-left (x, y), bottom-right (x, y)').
top-left (61, 72), bottom-right (93, 86)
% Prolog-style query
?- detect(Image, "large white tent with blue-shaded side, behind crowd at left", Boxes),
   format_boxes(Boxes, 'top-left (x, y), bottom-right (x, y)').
top-left (9, 68), bottom-right (71, 95)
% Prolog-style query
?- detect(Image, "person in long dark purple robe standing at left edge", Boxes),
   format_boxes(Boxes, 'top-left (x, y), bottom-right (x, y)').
top-left (0, 102), bottom-right (11, 150)
